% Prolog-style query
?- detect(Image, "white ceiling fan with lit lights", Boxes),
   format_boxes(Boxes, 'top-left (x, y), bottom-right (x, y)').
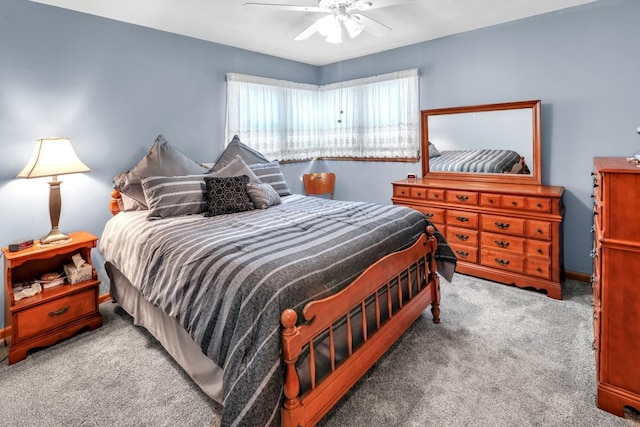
top-left (244, 0), bottom-right (407, 43)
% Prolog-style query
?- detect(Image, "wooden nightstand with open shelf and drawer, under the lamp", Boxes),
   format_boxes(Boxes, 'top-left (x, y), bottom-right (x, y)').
top-left (2, 231), bottom-right (102, 364)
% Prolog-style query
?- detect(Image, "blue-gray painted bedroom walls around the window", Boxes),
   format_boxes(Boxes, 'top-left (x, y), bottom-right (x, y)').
top-left (0, 0), bottom-right (640, 327)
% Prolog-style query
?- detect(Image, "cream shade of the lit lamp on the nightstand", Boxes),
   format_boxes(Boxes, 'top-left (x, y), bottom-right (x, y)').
top-left (18, 138), bottom-right (91, 178)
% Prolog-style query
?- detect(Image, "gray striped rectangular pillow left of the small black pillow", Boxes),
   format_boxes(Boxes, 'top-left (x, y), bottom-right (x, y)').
top-left (142, 175), bottom-right (207, 220)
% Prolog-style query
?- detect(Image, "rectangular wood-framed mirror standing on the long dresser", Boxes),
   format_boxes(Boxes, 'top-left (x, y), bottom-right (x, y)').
top-left (421, 100), bottom-right (542, 185)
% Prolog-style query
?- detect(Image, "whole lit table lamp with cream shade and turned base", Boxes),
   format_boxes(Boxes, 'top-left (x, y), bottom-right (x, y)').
top-left (18, 138), bottom-right (90, 244)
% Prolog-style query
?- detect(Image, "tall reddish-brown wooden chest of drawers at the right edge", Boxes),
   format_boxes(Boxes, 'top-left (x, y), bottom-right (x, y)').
top-left (591, 157), bottom-right (640, 416)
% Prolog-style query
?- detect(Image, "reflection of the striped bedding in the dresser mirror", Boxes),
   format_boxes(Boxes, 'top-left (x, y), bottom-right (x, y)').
top-left (429, 150), bottom-right (521, 173)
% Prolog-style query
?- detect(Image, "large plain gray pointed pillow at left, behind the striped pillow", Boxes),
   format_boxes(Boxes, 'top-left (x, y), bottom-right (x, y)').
top-left (113, 135), bottom-right (208, 209)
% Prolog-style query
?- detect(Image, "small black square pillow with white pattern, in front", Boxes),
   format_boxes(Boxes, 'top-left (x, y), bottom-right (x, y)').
top-left (204, 175), bottom-right (253, 216)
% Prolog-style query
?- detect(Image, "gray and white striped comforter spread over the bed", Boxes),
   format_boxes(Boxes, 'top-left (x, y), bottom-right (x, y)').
top-left (99, 195), bottom-right (455, 425)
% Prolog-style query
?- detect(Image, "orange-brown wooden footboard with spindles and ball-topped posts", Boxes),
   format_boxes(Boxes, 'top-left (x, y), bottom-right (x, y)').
top-left (280, 226), bottom-right (440, 427)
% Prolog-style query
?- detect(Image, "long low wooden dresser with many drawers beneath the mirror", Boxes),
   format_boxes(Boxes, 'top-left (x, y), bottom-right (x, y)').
top-left (392, 178), bottom-right (564, 299)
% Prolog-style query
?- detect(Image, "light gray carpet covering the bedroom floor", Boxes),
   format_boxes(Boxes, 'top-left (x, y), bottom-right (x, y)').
top-left (0, 275), bottom-right (635, 427)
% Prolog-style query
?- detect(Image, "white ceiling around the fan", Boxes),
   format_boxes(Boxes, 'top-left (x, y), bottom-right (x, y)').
top-left (31, 0), bottom-right (596, 65)
